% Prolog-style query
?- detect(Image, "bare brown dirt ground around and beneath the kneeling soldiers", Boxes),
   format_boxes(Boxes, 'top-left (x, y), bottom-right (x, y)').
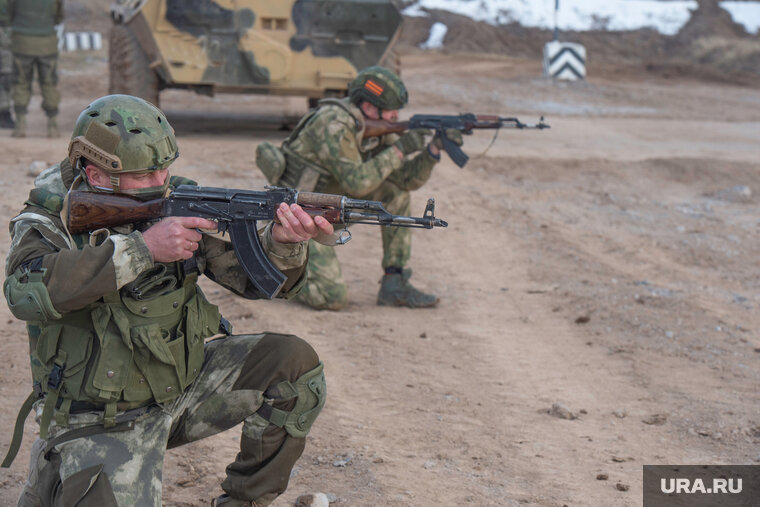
top-left (0, 45), bottom-right (760, 507)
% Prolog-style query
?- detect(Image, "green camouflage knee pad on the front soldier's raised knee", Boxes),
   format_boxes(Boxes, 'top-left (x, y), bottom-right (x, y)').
top-left (258, 361), bottom-right (327, 438)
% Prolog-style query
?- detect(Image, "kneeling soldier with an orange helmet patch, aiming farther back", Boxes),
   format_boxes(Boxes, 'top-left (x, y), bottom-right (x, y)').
top-left (256, 66), bottom-right (462, 310)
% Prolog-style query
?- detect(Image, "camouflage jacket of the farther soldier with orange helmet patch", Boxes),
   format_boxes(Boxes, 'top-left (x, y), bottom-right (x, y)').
top-left (285, 99), bottom-right (438, 198)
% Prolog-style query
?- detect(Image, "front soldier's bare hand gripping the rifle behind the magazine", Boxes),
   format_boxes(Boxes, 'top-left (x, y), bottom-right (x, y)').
top-left (142, 217), bottom-right (217, 262)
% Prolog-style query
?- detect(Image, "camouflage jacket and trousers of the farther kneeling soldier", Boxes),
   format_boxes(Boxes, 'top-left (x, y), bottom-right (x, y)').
top-left (280, 98), bottom-right (440, 309)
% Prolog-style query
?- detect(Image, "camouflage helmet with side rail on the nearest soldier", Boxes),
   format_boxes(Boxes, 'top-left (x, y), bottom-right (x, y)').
top-left (69, 95), bottom-right (179, 191)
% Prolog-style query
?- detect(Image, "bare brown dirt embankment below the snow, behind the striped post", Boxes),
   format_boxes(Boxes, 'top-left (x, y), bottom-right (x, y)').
top-left (400, 0), bottom-right (760, 86)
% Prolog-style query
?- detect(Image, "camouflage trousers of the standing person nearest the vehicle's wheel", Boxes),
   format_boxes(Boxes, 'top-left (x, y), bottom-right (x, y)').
top-left (12, 54), bottom-right (61, 116)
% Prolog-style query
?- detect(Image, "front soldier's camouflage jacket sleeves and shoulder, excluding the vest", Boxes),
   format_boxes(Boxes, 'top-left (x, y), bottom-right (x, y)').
top-left (5, 160), bottom-right (307, 313)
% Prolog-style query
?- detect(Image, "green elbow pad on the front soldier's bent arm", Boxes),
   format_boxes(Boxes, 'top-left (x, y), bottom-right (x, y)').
top-left (3, 268), bottom-right (61, 322)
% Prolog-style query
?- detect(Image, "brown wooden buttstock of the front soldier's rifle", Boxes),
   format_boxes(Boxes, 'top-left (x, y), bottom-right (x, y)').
top-left (67, 190), bottom-right (164, 234)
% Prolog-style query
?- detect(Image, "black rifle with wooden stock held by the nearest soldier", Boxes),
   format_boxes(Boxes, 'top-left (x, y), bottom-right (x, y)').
top-left (67, 185), bottom-right (448, 299)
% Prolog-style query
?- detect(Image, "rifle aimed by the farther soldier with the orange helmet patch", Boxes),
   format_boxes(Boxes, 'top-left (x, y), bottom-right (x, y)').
top-left (364, 113), bottom-right (551, 167)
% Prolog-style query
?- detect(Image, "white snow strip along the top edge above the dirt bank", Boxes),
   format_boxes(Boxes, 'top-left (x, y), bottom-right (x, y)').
top-left (404, 0), bottom-right (760, 38)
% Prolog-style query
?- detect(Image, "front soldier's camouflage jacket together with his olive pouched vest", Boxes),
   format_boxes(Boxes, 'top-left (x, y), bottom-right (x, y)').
top-left (4, 160), bottom-right (307, 422)
